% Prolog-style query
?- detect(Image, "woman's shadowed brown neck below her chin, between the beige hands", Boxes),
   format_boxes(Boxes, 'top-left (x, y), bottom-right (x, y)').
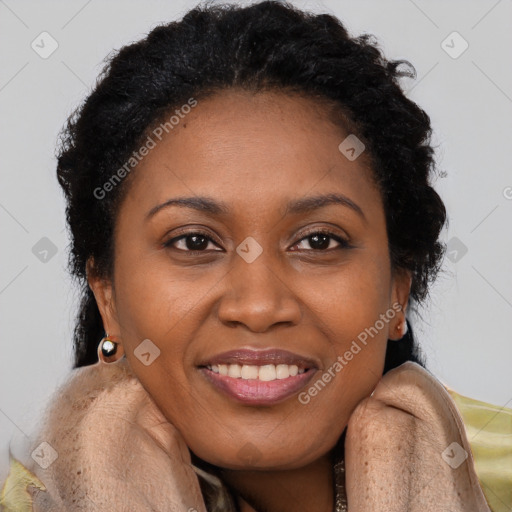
top-left (221, 454), bottom-right (334, 512)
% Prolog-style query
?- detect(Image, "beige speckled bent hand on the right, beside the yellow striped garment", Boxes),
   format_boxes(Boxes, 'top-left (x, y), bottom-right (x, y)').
top-left (345, 362), bottom-right (490, 512)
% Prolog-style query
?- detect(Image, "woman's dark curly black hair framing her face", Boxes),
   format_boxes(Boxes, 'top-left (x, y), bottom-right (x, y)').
top-left (57, 1), bottom-right (446, 372)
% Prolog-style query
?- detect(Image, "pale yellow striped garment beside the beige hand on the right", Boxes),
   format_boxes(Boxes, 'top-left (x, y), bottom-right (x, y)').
top-left (445, 386), bottom-right (512, 512)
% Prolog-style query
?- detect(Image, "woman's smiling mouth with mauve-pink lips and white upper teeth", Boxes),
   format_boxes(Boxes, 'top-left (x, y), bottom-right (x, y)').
top-left (199, 349), bottom-right (319, 405)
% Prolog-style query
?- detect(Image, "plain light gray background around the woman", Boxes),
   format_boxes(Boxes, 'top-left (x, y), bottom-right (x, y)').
top-left (0, 0), bottom-right (512, 478)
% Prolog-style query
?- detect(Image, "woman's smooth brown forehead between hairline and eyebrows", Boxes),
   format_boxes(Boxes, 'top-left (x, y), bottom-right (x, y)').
top-left (119, 90), bottom-right (379, 220)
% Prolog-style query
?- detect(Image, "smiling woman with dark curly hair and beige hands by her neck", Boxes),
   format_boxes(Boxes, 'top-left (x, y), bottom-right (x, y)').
top-left (0, 2), bottom-right (508, 512)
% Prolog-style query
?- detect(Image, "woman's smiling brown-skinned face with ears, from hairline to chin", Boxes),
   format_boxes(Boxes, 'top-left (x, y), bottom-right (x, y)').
top-left (90, 91), bottom-right (410, 469)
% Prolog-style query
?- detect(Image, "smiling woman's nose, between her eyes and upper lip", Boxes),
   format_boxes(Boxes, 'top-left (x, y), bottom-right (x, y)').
top-left (218, 252), bottom-right (302, 333)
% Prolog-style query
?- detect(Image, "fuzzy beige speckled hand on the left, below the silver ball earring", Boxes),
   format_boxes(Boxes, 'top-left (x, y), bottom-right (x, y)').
top-left (29, 363), bottom-right (206, 512)
